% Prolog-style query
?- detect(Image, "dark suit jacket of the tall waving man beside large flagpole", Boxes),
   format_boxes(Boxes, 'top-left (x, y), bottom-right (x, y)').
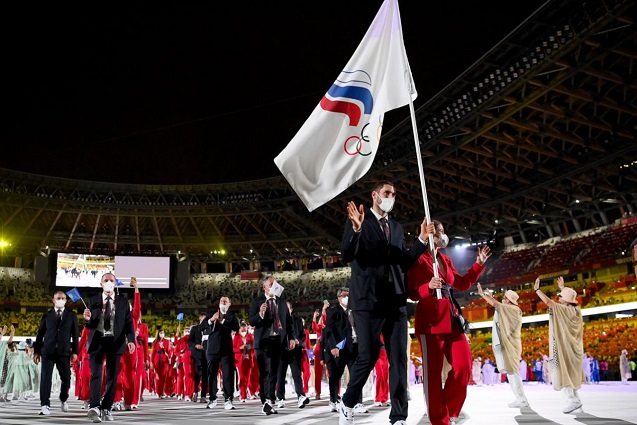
top-left (341, 210), bottom-right (426, 310)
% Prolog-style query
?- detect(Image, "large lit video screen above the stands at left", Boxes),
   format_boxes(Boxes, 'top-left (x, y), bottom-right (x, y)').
top-left (55, 252), bottom-right (171, 290)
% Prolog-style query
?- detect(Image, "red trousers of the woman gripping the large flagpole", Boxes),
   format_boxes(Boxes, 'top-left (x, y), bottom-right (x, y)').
top-left (420, 332), bottom-right (471, 425)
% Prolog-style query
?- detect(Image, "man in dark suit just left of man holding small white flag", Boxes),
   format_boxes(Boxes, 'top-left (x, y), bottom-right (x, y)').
top-left (202, 297), bottom-right (239, 410)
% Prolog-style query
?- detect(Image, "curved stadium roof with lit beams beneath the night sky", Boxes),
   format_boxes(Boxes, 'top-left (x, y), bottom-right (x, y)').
top-left (0, 0), bottom-right (637, 268)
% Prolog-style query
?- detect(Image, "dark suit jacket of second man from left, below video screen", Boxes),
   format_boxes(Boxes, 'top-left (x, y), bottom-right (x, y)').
top-left (86, 292), bottom-right (135, 354)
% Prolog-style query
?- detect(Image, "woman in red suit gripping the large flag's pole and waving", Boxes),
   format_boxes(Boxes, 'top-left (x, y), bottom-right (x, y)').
top-left (407, 220), bottom-right (491, 425)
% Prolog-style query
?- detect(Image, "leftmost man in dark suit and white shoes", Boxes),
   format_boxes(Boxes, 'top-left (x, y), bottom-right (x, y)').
top-left (33, 291), bottom-right (79, 415)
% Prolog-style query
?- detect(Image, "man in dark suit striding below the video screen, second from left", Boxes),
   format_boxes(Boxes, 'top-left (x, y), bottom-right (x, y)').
top-left (84, 273), bottom-right (135, 422)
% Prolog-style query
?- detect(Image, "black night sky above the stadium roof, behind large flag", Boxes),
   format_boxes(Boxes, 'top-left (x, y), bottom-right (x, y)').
top-left (0, 0), bottom-right (544, 184)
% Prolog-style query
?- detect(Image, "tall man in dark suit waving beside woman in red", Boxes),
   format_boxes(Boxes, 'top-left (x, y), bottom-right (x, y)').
top-left (339, 181), bottom-right (427, 424)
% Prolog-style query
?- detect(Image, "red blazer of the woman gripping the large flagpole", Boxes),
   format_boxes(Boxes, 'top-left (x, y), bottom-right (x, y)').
top-left (407, 251), bottom-right (485, 335)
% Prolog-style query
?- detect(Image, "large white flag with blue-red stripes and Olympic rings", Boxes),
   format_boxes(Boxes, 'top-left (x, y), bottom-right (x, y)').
top-left (274, 0), bottom-right (417, 211)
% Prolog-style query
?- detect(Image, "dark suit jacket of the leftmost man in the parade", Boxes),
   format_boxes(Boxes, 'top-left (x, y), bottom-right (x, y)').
top-left (33, 308), bottom-right (79, 357)
